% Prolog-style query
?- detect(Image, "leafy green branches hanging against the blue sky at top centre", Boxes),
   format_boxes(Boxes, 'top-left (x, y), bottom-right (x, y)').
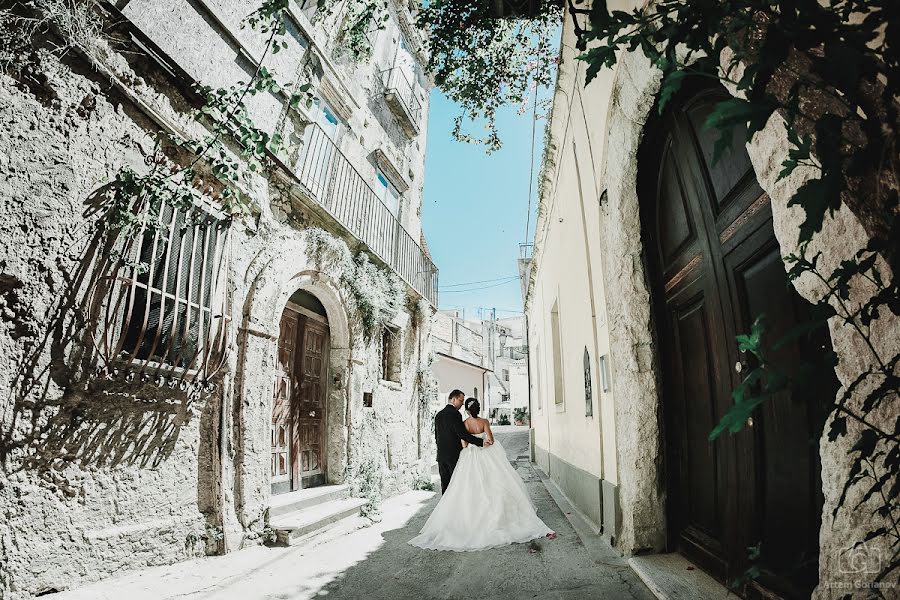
top-left (417, 0), bottom-right (562, 153)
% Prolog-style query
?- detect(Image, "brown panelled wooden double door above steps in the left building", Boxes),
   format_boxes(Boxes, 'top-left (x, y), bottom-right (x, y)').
top-left (271, 307), bottom-right (329, 494)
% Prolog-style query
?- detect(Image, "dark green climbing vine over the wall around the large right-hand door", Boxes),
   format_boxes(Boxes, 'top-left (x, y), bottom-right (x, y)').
top-left (567, 0), bottom-right (900, 581)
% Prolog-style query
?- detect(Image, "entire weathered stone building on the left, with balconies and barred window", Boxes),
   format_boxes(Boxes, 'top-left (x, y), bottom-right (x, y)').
top-left (0, 0), bottom-right (437, 600)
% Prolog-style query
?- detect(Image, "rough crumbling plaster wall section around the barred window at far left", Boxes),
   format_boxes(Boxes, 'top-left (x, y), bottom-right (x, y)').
top-left (0, 52), bottom-right (217, 598)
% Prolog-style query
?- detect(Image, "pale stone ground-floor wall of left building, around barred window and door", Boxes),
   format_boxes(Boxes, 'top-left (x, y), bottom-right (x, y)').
top-left (0, 3), bottom-right (433, 600)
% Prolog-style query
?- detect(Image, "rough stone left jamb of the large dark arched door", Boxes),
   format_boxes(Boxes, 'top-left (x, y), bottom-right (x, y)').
top-left (600, 52), bottom-right (666, 553)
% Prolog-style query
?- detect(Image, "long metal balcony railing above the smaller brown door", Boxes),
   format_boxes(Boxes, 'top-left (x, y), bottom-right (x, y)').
top-left (294, 123), bottom-right (438, 306)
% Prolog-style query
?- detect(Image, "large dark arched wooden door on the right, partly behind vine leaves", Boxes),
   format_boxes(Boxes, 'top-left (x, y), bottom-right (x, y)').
top-left (638, 82), bottom-right (836, 597)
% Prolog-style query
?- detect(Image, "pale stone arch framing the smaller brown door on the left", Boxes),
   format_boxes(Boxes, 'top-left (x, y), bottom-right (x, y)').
top-left (234, 238), bottom-right (355, 530)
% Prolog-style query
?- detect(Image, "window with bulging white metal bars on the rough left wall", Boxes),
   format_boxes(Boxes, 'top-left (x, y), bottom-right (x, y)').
top-left (99, 198), bottom-right (229, 381)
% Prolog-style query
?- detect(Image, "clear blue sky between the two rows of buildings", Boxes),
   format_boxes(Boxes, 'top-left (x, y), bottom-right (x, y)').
top-left (422, 89), bottom-right (550, 318)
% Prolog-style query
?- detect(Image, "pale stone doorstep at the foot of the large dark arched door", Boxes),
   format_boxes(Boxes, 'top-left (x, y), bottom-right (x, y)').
top-left (628, 552), bottom-right (731, 600)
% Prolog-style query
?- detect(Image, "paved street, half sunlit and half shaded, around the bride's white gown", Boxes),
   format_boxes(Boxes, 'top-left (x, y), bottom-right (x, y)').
top-left (56, 428), bottom-right (653, 600)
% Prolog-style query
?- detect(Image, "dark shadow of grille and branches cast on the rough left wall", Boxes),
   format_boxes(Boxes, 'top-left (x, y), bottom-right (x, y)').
top-left (0, 186), bottom-right (199, 497)
